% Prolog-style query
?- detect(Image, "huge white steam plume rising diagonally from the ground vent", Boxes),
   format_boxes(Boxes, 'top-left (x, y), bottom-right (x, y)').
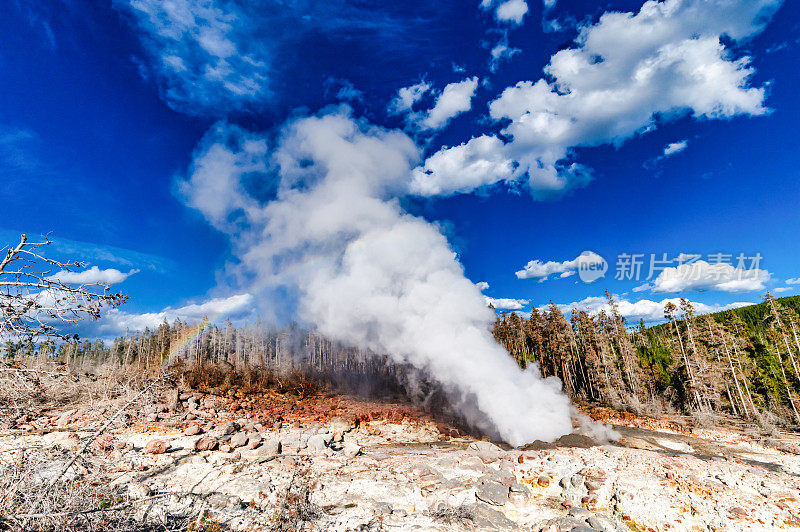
top-left (181, 106), bottom-right (572, 445)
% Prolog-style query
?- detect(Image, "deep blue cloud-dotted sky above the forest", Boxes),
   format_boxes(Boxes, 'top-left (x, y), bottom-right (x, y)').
top-left (0, 0), bottom-right (800, 336)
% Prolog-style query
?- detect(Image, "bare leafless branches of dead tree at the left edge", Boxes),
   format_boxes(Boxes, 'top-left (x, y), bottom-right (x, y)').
top-left (0, 235), bottom-right (126, 342)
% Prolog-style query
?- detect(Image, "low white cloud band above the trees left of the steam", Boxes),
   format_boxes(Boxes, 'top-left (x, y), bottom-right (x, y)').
top-left (96, 294), bottom-right (254, 338)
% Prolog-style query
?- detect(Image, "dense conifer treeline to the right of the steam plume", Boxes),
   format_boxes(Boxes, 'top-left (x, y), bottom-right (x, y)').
top-left (494, 293), bottom-right (800, 425)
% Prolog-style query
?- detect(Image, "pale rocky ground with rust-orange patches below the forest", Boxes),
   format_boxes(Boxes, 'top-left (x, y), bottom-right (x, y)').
top-left (0, 370), bottom-right (800, 532)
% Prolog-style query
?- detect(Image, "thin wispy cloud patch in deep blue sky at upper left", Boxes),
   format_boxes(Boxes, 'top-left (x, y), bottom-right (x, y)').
top-left (116, 0), bottom-right (270, 114)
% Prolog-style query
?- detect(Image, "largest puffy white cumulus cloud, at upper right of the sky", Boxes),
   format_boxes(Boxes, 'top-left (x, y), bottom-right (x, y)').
top-left (418, 0), bottom-right (781, 199)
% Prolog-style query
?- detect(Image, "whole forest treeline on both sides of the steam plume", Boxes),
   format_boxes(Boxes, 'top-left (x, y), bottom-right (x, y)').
top-left (4, 294), bottom-right (800, 425)
